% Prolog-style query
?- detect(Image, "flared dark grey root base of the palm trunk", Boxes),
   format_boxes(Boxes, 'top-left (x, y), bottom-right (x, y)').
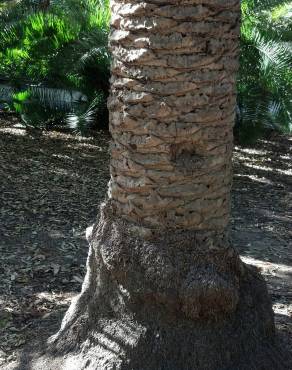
top-left (32, 206), bottom-right (290, 370)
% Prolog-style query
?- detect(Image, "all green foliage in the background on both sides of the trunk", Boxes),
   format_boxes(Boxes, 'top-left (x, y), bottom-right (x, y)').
top-left (0, 0), bottom-right (292, 141)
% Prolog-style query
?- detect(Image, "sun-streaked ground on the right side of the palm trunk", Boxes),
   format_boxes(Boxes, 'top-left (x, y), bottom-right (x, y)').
top-left (231, 137), bottom-right (292, 358)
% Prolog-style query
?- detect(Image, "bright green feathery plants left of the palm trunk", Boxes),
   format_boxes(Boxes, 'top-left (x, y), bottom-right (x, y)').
top-left (0, 0), bottom-right (109, 133)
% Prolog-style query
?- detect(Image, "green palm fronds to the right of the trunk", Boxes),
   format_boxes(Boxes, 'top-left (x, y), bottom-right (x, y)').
top-left (235, 0), bottom-right (292, 141)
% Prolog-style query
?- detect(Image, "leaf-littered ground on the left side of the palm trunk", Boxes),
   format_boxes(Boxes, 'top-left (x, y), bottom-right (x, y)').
top-left (0, 127), bottom-right (109, 367)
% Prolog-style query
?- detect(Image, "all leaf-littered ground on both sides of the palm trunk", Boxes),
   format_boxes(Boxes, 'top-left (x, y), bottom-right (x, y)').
top-left (0, 117), bottom-right (292, 370)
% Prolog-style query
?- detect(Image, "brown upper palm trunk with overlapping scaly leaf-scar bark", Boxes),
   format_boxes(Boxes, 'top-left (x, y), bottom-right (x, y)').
top-left (109, 0), bottom-right (240, 230)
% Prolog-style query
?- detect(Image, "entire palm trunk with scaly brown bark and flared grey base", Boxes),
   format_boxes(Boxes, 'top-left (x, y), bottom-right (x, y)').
top-left (39, 0), bottom-right (285, 370)
